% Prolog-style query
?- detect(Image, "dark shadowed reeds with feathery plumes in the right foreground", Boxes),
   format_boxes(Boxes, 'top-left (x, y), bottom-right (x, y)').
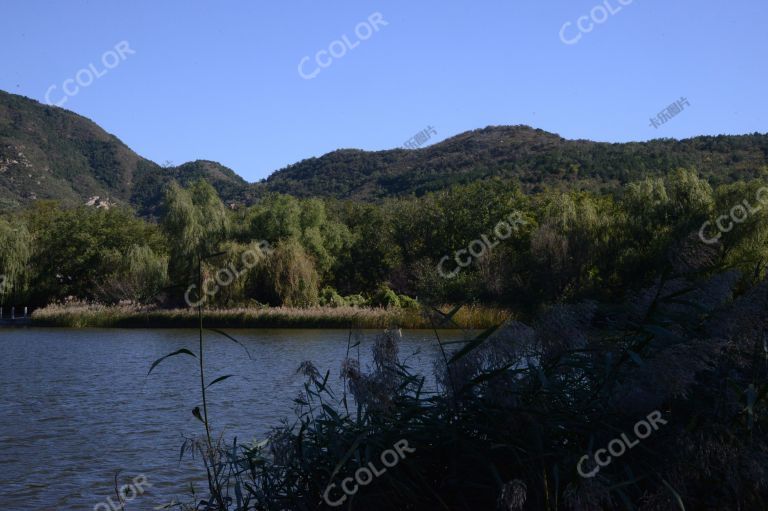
top-left (174, 266), bottom-right (768, 511)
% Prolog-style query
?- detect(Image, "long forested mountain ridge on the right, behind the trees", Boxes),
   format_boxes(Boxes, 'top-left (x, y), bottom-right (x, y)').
top-left (265, 126), bottom-right (768, 200)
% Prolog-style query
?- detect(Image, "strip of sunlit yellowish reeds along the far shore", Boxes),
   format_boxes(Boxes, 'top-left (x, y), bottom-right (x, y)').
top-left (32, 304), bottom-right (509, 328)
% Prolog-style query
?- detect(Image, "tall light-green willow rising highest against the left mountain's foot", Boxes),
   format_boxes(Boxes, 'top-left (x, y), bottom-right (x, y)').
top-left (163, 180), bottom-right (230, 294)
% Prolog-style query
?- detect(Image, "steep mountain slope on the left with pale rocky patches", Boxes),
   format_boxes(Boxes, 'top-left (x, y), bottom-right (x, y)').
top-left (0, 91), bottom-right (253, 215)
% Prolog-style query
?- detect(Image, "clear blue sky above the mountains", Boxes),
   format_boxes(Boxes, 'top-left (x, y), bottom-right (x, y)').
top-left (0, 0), bottom-right (768, 181)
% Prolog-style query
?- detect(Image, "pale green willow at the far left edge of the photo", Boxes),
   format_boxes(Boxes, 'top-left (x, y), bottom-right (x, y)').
top-left (0, 218), bottom-right (32, 303)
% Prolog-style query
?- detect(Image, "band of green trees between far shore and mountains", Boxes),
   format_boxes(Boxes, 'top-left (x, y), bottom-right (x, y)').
top-left (0, 170), bottom-right (768, 313)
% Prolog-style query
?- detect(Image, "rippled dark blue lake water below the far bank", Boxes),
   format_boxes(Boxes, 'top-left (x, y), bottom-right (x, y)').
top-left (0, 328), bottom-right (462, 510)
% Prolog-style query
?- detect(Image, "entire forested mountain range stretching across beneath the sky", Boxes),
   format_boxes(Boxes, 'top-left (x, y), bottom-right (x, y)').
top-left (0, 91), bottom-right (768, 212)
